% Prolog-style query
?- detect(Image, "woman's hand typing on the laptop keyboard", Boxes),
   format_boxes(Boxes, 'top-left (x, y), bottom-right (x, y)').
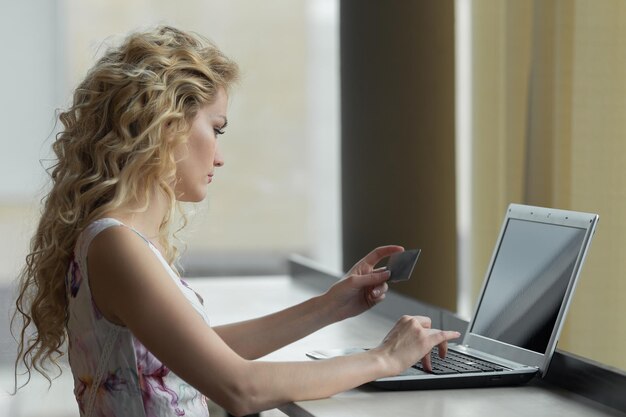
top-left (374, 316), bottom-right (461, 376)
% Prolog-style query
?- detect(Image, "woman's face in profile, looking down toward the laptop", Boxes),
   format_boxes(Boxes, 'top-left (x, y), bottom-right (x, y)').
top-left (174, 88), bottom-right (228, 202)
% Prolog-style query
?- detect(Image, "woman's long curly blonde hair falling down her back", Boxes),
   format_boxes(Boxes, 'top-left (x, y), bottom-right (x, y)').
top-left (12, 26), bottom-right (239, 391)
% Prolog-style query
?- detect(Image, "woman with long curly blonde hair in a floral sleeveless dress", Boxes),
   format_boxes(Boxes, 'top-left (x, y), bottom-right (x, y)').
top-left (16, 27), bottom-right (458, 416)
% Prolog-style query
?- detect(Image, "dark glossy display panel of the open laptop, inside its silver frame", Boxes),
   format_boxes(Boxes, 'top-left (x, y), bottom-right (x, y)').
top-left (470, 218), bottom-right (586, 353)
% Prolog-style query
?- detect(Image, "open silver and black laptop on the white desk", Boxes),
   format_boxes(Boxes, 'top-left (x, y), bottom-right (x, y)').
top-left (307, 204), bottom-right (598, 390)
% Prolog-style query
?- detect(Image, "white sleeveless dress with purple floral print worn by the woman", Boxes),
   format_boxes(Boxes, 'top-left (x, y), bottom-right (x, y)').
top-left (65, 218), bottom-right (209, 417)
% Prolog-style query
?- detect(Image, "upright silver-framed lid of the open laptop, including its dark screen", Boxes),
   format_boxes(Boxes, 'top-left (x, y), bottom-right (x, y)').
top-left (462, 204), bottom-right (598, 374)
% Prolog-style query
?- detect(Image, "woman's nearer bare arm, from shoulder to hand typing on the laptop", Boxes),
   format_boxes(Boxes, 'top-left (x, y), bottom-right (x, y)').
top-left (88, 228), bottom-right (456, 415)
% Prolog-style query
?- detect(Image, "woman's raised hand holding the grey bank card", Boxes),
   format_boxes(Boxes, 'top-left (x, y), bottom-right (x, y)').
top-left (324, 245), bottom-right (404, 321)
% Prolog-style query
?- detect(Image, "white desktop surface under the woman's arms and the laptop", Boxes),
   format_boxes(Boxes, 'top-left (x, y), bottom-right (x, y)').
top-left (192, 276), bottom-right (623, 417)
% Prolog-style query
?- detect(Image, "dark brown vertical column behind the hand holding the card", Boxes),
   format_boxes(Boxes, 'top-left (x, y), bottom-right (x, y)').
top-left (340, 0), bottom-right (456, 310)
